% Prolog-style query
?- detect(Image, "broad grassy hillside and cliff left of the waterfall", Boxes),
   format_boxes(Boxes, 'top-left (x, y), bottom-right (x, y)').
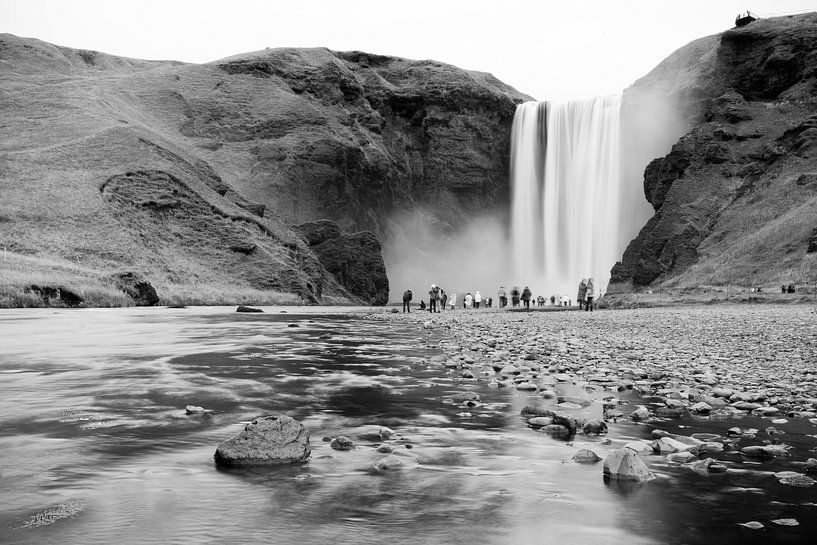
top-left (0, 35), bottom-right (526, 303)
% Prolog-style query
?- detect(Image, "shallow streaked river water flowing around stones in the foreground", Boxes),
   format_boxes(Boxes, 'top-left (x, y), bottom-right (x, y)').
top-left (0, 308), bottom-right (817, 545)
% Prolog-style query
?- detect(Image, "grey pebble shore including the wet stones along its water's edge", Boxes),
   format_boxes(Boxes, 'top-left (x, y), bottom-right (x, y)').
top-left (370, 305), bottom-right (817, 487)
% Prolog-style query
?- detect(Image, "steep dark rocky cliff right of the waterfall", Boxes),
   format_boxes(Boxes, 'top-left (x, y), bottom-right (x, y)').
top-left (612, 13), bottom-right (817, 286)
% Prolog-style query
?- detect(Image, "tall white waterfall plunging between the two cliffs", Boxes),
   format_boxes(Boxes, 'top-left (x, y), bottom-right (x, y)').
top-left (511, 96), bottom-right (631, 300)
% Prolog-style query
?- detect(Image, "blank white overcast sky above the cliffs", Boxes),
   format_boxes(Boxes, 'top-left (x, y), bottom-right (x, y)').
top-left (0, 0), bottom-right (817, 100)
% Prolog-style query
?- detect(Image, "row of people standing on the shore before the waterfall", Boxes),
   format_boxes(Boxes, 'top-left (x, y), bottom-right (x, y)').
top-left (403, 278), bottom-right (596, 312)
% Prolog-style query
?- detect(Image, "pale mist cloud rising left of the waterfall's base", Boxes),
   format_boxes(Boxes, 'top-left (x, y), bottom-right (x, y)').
top-left (383, 209), bottom-right (511, 305)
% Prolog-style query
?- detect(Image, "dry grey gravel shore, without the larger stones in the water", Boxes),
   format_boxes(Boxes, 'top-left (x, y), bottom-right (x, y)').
top-left (370, 305), bottom-right (817, 422)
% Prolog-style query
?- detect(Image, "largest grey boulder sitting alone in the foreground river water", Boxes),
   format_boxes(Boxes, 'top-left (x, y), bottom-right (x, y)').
top-left (215, 415), bottom-right (310, 466)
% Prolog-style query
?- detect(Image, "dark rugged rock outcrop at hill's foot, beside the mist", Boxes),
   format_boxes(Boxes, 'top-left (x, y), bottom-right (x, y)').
top-left (296, 220), bottom-right (389, 305)
